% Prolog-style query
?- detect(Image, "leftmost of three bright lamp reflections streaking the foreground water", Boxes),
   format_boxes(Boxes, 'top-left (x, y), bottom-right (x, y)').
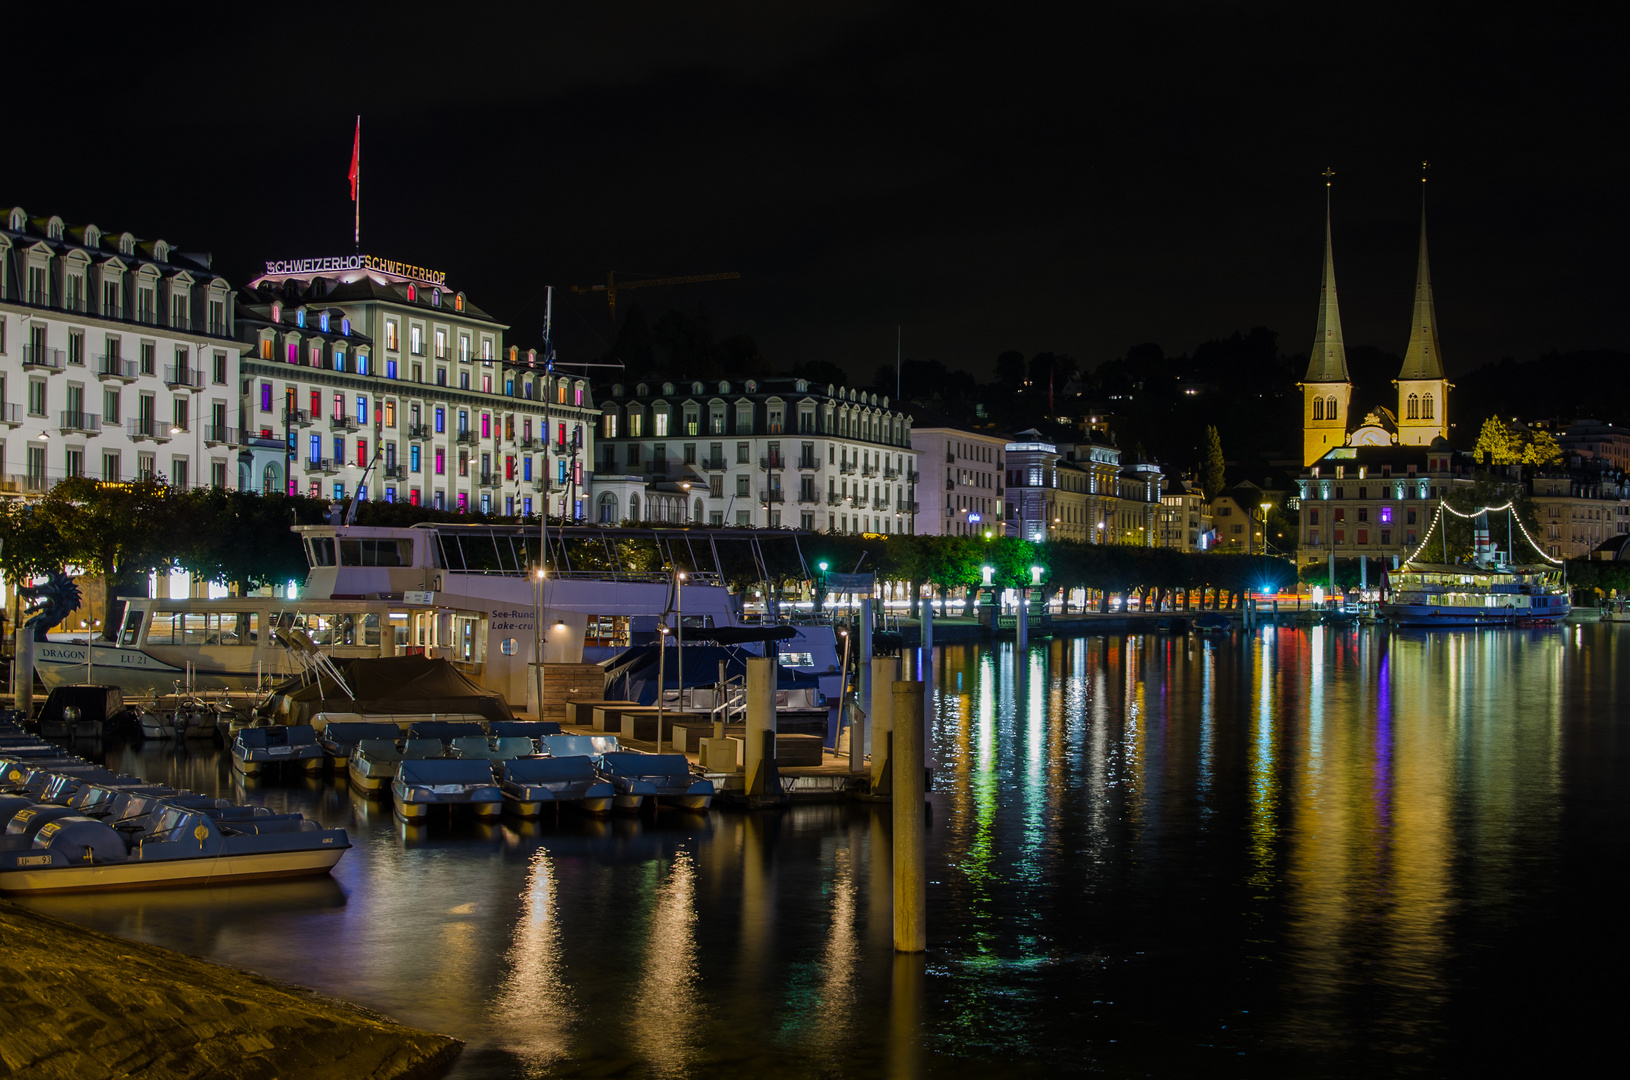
top-left (492, 849), bottom-right (577, 1075)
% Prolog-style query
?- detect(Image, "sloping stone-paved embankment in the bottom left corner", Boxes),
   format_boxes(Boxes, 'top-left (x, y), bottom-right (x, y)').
top-left (0, 901), bottom-right (461, 1080)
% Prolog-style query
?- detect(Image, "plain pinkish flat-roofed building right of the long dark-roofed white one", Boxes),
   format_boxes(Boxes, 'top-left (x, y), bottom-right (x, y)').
top-left (911, 409), bottom-right (1011, 536)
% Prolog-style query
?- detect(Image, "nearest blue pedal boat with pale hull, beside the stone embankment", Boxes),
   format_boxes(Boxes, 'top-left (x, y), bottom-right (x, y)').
top-left (0, 806), bottom-right (350, 894)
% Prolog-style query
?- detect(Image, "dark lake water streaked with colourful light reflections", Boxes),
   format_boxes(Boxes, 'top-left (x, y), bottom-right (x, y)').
top-left (25, 626), bottom-right (1630, 1078)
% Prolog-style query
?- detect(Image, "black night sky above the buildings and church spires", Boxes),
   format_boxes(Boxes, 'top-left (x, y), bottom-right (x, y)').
top-left (9, 2), bottom-right (1630, 380)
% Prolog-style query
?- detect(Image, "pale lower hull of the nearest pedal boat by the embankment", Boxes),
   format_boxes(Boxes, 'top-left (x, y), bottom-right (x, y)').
top-left (0, 847), bottom-right (347, 893)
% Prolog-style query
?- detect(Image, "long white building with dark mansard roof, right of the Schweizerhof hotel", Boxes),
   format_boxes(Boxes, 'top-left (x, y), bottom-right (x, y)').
top-left (593, 376), bottom-right (921, 533)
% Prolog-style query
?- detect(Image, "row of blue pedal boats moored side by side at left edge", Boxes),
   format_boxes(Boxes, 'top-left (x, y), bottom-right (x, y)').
top-left (0, 722), bottom-right (350, 893)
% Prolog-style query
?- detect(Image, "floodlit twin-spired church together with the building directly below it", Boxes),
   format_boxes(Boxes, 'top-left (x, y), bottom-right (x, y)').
top-left (1297, 185), bottom-right (1472, 570)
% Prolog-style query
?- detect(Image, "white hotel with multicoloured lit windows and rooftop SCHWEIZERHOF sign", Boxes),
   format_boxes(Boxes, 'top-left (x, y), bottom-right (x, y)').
top-left (238, 256), bottom-right (600, 518)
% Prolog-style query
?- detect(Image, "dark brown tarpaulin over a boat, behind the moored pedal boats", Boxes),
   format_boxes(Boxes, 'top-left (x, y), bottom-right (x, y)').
top-left (274, 655), bottom-right (515, 723)
